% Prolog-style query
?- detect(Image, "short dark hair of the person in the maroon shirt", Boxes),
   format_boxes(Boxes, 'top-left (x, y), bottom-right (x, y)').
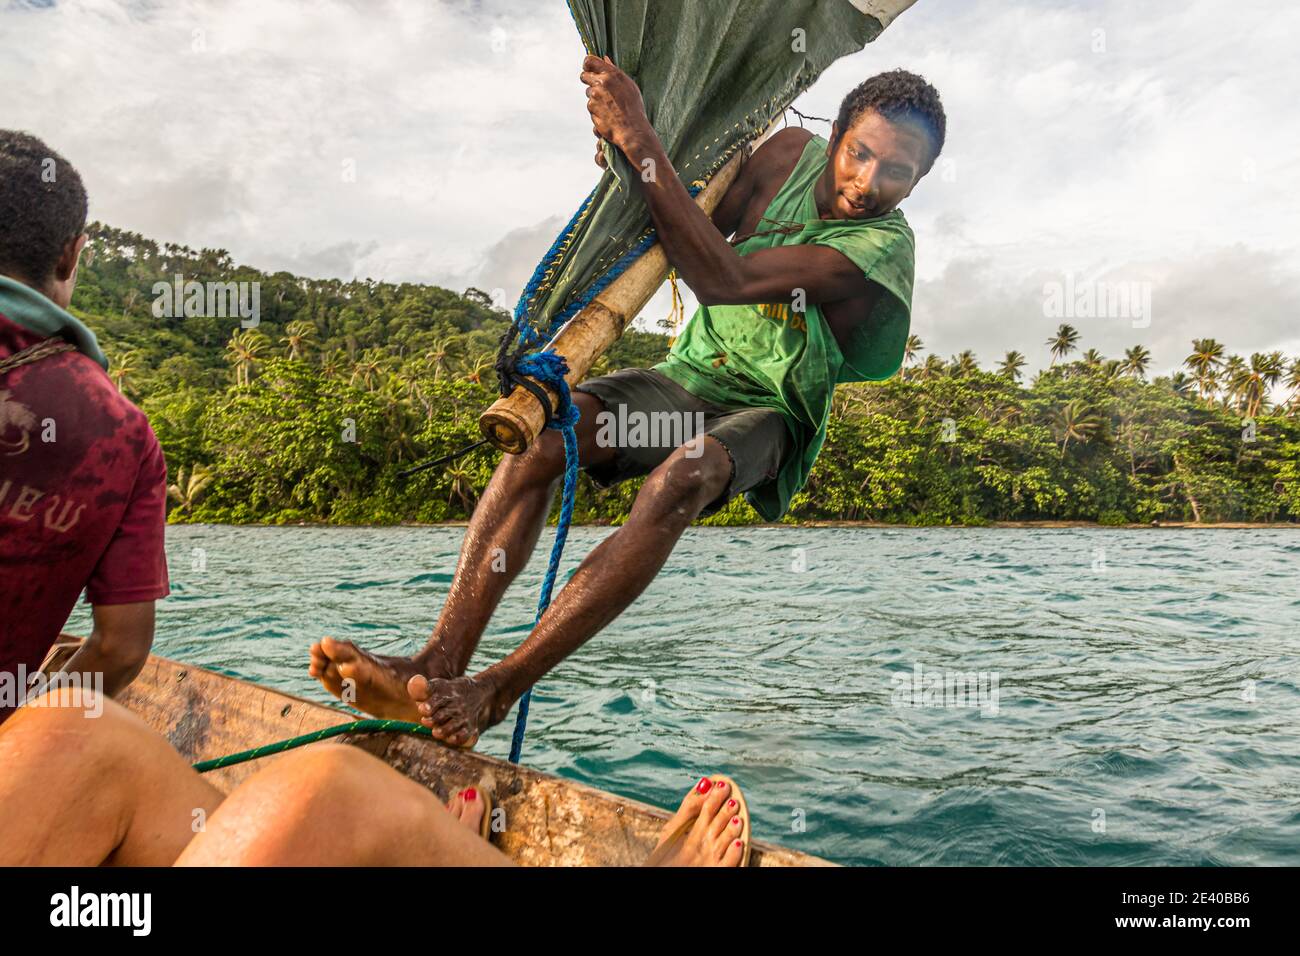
top-left (0, 130), bottom-right (88, 282)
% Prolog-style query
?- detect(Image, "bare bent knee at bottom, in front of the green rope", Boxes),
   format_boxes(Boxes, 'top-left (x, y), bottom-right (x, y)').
top-left (177, 744), bottom-right (514, 866)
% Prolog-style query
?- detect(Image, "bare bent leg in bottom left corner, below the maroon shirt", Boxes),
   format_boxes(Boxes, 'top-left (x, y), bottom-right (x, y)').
top-left (0, 691), bottom-right (222, 866)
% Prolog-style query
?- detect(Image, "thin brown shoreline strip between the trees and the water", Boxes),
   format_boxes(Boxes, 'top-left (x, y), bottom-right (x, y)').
top-left (168, 520), bottom-right (1300, 531)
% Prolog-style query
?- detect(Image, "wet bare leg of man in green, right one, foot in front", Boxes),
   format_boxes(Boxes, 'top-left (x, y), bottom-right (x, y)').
top-left (408, 436), bottom-right (731, 747)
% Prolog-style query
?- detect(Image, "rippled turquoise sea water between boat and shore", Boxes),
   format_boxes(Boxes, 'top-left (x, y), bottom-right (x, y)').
top-left (69, 525), bottom-right (1300, 865)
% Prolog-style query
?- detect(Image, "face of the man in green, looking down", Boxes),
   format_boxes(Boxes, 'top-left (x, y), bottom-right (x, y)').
top-left (823, 111), bottom-right (930, 219)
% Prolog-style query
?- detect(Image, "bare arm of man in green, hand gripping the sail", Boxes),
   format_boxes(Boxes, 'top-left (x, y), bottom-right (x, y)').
top-left (582, 56), bottom-right (870, 306)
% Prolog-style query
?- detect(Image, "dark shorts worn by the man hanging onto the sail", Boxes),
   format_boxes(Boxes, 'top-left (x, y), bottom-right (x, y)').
top-left (573, 368), bottom-right (794, 516)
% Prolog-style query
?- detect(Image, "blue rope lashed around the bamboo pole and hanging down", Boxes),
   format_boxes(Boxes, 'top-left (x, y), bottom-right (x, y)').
top-left (502, 180), bottom-right (701, 763)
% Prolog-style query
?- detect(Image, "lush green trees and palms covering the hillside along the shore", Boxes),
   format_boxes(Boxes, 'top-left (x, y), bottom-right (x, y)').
top-left (72, 224), bottom-right (1300, 527)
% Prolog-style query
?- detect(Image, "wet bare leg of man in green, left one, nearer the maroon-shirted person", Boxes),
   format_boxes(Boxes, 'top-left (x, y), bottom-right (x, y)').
top-left (308, 392), bottom-right (615, 721)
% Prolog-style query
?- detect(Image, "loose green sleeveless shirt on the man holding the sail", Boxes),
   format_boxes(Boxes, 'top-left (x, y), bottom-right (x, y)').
top-left (653, 137), bottom-right (915, 522)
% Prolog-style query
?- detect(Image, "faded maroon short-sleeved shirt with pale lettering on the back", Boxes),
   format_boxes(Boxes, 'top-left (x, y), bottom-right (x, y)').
top-left (0, 315), bottom-right (168, 719)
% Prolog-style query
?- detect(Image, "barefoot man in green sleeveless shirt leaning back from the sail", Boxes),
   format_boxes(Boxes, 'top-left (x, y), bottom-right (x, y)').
top-left (311, 56), bottom-right (946, 745)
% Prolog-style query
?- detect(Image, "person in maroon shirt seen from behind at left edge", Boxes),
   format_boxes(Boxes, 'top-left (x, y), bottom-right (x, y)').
top-left (0, 130), bottom-right (168, 722)
